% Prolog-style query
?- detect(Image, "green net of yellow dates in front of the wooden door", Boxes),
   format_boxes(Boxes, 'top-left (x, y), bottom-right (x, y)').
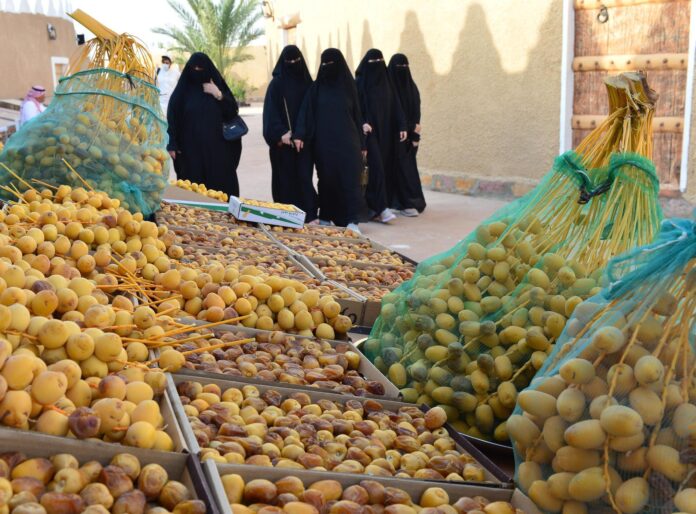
top-left (364, 148), bottom-right (661, 442)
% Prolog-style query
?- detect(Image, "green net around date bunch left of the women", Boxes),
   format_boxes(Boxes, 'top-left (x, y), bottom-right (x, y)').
top-left (0, 68), bottom-right (169, 215)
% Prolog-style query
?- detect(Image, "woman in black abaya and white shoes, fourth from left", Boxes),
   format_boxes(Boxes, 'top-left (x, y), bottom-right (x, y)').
top-left (355, 48), bottom-right (406, 223)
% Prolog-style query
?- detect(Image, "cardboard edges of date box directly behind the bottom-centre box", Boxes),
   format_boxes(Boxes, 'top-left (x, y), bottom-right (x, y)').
top-left (167, 373), bottom-right (512, 488)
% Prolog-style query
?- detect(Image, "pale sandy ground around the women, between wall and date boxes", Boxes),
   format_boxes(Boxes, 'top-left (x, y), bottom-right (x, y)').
top-left (237, 106), bottom-right (505, 262)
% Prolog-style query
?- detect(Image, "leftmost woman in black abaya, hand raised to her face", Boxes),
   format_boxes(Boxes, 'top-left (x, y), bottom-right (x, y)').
top-left (167, 52), bottom-right (242, 196)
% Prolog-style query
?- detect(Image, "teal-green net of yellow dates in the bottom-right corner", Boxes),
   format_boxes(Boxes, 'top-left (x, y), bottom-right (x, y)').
top-left (507, 219), bottom-right (696, 513)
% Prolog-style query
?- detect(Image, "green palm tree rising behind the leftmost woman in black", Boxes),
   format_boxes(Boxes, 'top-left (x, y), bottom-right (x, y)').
top-left (153, 0), bottom-right (262, 80)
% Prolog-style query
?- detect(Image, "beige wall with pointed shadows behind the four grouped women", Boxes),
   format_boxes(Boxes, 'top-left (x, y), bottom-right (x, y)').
top-left (266, 0), bottom-right (562, 182)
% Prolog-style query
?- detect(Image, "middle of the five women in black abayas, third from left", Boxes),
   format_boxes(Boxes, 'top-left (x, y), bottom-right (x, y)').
top-left (293, 48), bottom-right (366, 233)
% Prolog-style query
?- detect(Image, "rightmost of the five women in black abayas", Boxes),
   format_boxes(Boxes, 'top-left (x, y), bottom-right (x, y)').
top-left (388, 54), bottom-right (425, 212)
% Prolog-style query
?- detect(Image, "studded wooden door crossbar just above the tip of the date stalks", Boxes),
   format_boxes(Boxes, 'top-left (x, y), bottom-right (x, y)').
top-left (573, 54), bottom-right (689, 71)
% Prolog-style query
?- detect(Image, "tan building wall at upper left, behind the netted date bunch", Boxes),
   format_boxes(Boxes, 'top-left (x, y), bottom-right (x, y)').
top-left (0, 12), bottom-right (77, 98)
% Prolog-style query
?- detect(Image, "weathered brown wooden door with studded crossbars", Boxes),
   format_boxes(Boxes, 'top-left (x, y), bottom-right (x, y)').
top-left (572, 0), bottom-right (691, 192)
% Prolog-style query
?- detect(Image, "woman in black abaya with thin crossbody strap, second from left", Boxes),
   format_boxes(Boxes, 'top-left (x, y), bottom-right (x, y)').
top-left (263, 45), bottom-right (317, 222)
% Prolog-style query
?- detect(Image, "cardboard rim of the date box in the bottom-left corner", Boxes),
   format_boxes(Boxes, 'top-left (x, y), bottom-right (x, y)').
top-left (0, 428), bottom-right (219, 514)
